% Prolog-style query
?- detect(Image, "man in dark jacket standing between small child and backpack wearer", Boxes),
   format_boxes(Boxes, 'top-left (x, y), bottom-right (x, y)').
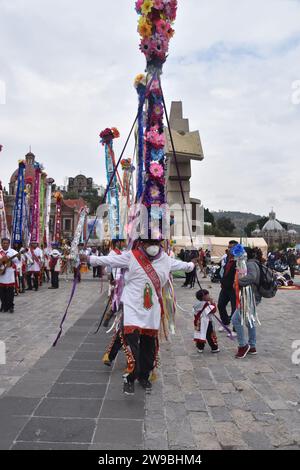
top-left (218, 240), bottom-right (238, 331)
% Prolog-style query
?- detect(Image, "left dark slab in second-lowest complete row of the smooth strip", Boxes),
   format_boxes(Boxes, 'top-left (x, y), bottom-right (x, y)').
top-left (34, 398), bottom-right (102, 418)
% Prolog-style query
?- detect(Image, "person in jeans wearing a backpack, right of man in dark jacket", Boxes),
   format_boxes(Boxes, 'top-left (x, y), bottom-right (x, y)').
top-left (232, 248), bottom-right (262, 359)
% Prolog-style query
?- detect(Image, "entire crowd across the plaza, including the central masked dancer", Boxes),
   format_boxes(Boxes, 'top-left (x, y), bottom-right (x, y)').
top-left (0, 238), bottom-right (298, 395)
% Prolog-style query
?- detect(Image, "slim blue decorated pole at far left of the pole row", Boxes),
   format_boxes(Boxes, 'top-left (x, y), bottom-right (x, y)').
top-left (12, 160), bottom-right (26, 243)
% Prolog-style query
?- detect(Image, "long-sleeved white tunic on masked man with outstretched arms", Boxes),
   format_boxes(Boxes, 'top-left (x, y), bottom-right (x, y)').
top-left (90, 251), bottom-right (195, 333)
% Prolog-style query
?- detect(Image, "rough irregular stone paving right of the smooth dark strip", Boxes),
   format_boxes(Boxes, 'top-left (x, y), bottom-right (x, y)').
top-left (145, 280), bottom-right (300, 450)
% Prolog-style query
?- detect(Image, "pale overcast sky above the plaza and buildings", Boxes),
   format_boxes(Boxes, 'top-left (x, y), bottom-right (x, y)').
top-left (0, 0), bottom-right (300, 223)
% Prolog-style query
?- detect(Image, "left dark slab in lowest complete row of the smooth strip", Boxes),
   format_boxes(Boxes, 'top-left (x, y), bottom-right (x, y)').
top-left (18, 418), bottom-right (96, 444)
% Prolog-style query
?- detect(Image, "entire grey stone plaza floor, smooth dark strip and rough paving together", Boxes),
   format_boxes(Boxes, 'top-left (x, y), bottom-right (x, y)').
top-left (0, 279), bottom-right (300, 450)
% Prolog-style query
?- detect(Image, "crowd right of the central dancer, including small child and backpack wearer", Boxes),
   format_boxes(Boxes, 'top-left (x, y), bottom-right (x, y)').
top-left (183, 240), bottom-right (300, 359)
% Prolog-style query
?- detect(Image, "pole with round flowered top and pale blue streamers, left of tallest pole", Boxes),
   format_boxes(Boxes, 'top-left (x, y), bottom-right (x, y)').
top-left (100, 127), bottom-right (123, 240)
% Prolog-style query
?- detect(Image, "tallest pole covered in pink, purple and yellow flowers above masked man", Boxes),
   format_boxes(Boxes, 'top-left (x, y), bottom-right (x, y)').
top-left (135, 0), bottom-right (177, 238)
